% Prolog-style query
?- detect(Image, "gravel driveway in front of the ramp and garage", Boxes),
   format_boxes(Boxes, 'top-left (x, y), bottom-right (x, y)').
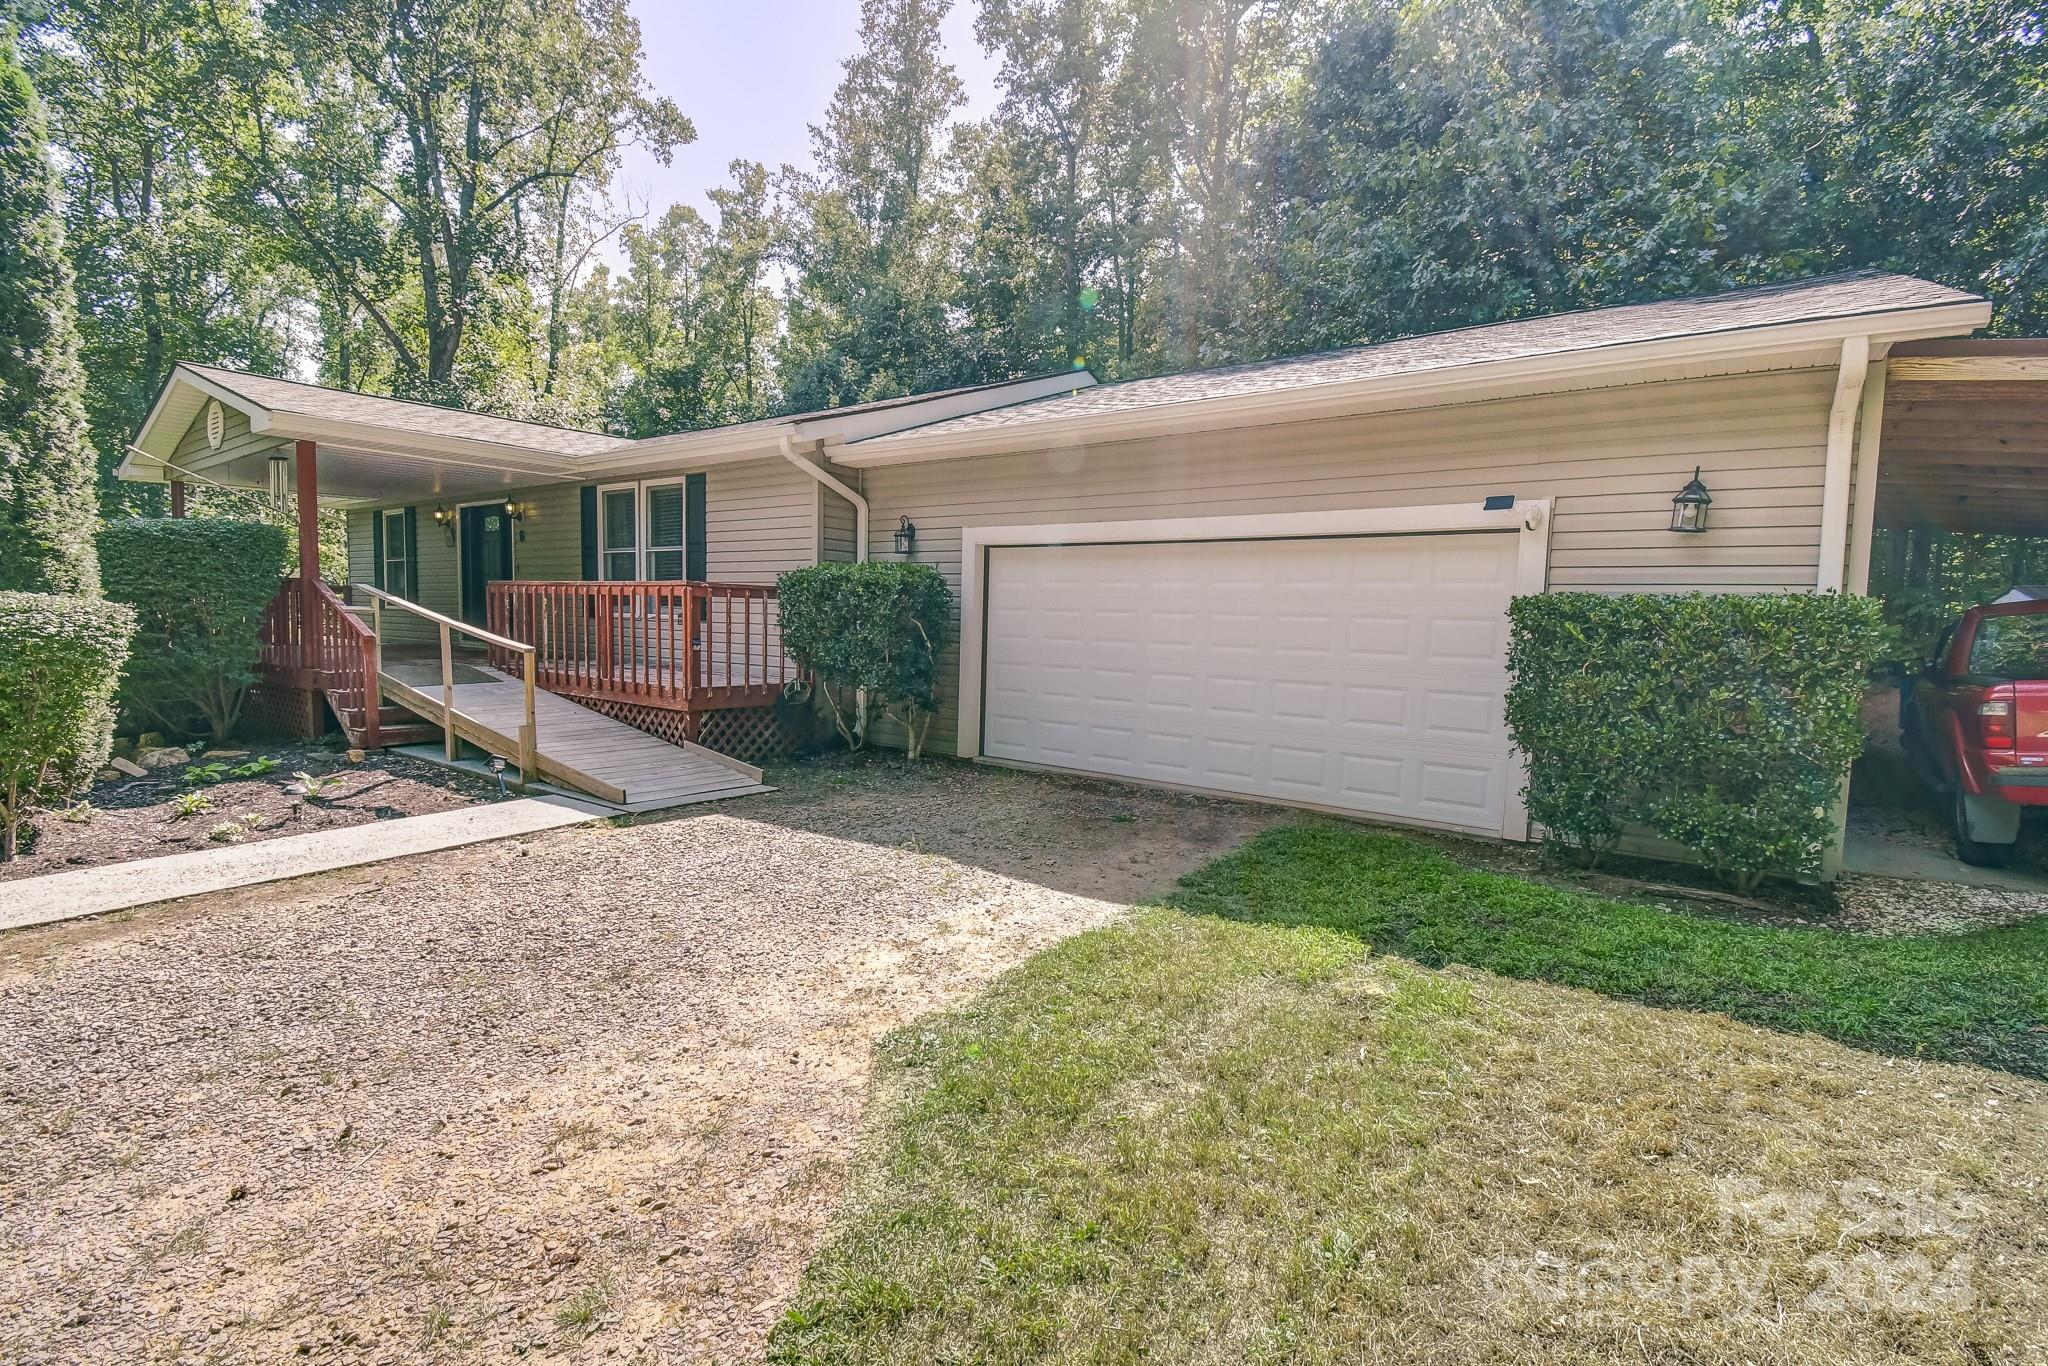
top-left (0, 762), bottom-right (1276, 1362)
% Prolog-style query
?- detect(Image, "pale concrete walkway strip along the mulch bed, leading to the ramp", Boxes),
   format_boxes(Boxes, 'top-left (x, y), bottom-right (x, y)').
top-left (0, 797), bottom-right (610, 930)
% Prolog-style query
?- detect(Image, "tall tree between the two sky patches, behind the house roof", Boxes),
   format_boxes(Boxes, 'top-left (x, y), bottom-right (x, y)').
top-left (780, 0), bottom-right (965, 408)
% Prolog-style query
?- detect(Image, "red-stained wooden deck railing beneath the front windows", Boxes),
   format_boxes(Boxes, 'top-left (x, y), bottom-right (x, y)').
top-left (489, 580), bottom-right (795, 711)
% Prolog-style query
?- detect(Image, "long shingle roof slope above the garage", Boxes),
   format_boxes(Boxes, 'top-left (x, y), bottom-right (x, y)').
top-left (854, 270), bottom-right (1976, 451)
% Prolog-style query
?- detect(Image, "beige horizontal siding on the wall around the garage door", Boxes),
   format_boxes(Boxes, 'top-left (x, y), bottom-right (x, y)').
top-left (864, 369), bottom-right (1835, 752)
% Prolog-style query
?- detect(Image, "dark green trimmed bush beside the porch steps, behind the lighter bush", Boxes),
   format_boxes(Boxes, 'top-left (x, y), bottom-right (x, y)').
top-left (100, 518), bottom-right (285, 739)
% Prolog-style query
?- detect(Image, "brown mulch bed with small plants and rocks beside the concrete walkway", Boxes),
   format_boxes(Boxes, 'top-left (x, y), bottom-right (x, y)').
top-left (0, 741), bottom-right (498, 881)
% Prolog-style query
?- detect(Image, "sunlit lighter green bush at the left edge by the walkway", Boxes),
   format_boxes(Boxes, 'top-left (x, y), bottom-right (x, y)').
top-left (0, 592), bottom-right (135, 862)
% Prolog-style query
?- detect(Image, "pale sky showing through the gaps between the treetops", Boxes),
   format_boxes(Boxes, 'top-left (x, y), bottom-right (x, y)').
top-left (616, 0), bottom-right (997, 240)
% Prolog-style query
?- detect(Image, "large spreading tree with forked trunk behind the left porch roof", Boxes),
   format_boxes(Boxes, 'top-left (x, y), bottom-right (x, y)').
top-left (209, 0), bottom-right (694, 399)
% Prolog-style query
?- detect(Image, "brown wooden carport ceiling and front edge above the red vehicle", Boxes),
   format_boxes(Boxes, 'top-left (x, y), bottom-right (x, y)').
top-left (1876, 338), bottom-right (2048, 537)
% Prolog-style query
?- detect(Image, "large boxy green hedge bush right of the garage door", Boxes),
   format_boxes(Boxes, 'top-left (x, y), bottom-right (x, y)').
top-left (1507, 594), bottom-right (1886, 891)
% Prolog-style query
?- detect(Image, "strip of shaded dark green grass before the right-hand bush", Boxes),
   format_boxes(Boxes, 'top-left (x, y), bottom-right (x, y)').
top-left (1167, 823), bottom-right (2048, 1079)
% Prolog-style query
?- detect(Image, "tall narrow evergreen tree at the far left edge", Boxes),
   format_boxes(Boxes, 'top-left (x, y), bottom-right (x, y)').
top-left (0, 29), bottom-right (100, 596)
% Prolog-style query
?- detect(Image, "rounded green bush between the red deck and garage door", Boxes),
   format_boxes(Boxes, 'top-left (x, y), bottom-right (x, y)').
top-left (776, 561), bottom-right (952, 758)
